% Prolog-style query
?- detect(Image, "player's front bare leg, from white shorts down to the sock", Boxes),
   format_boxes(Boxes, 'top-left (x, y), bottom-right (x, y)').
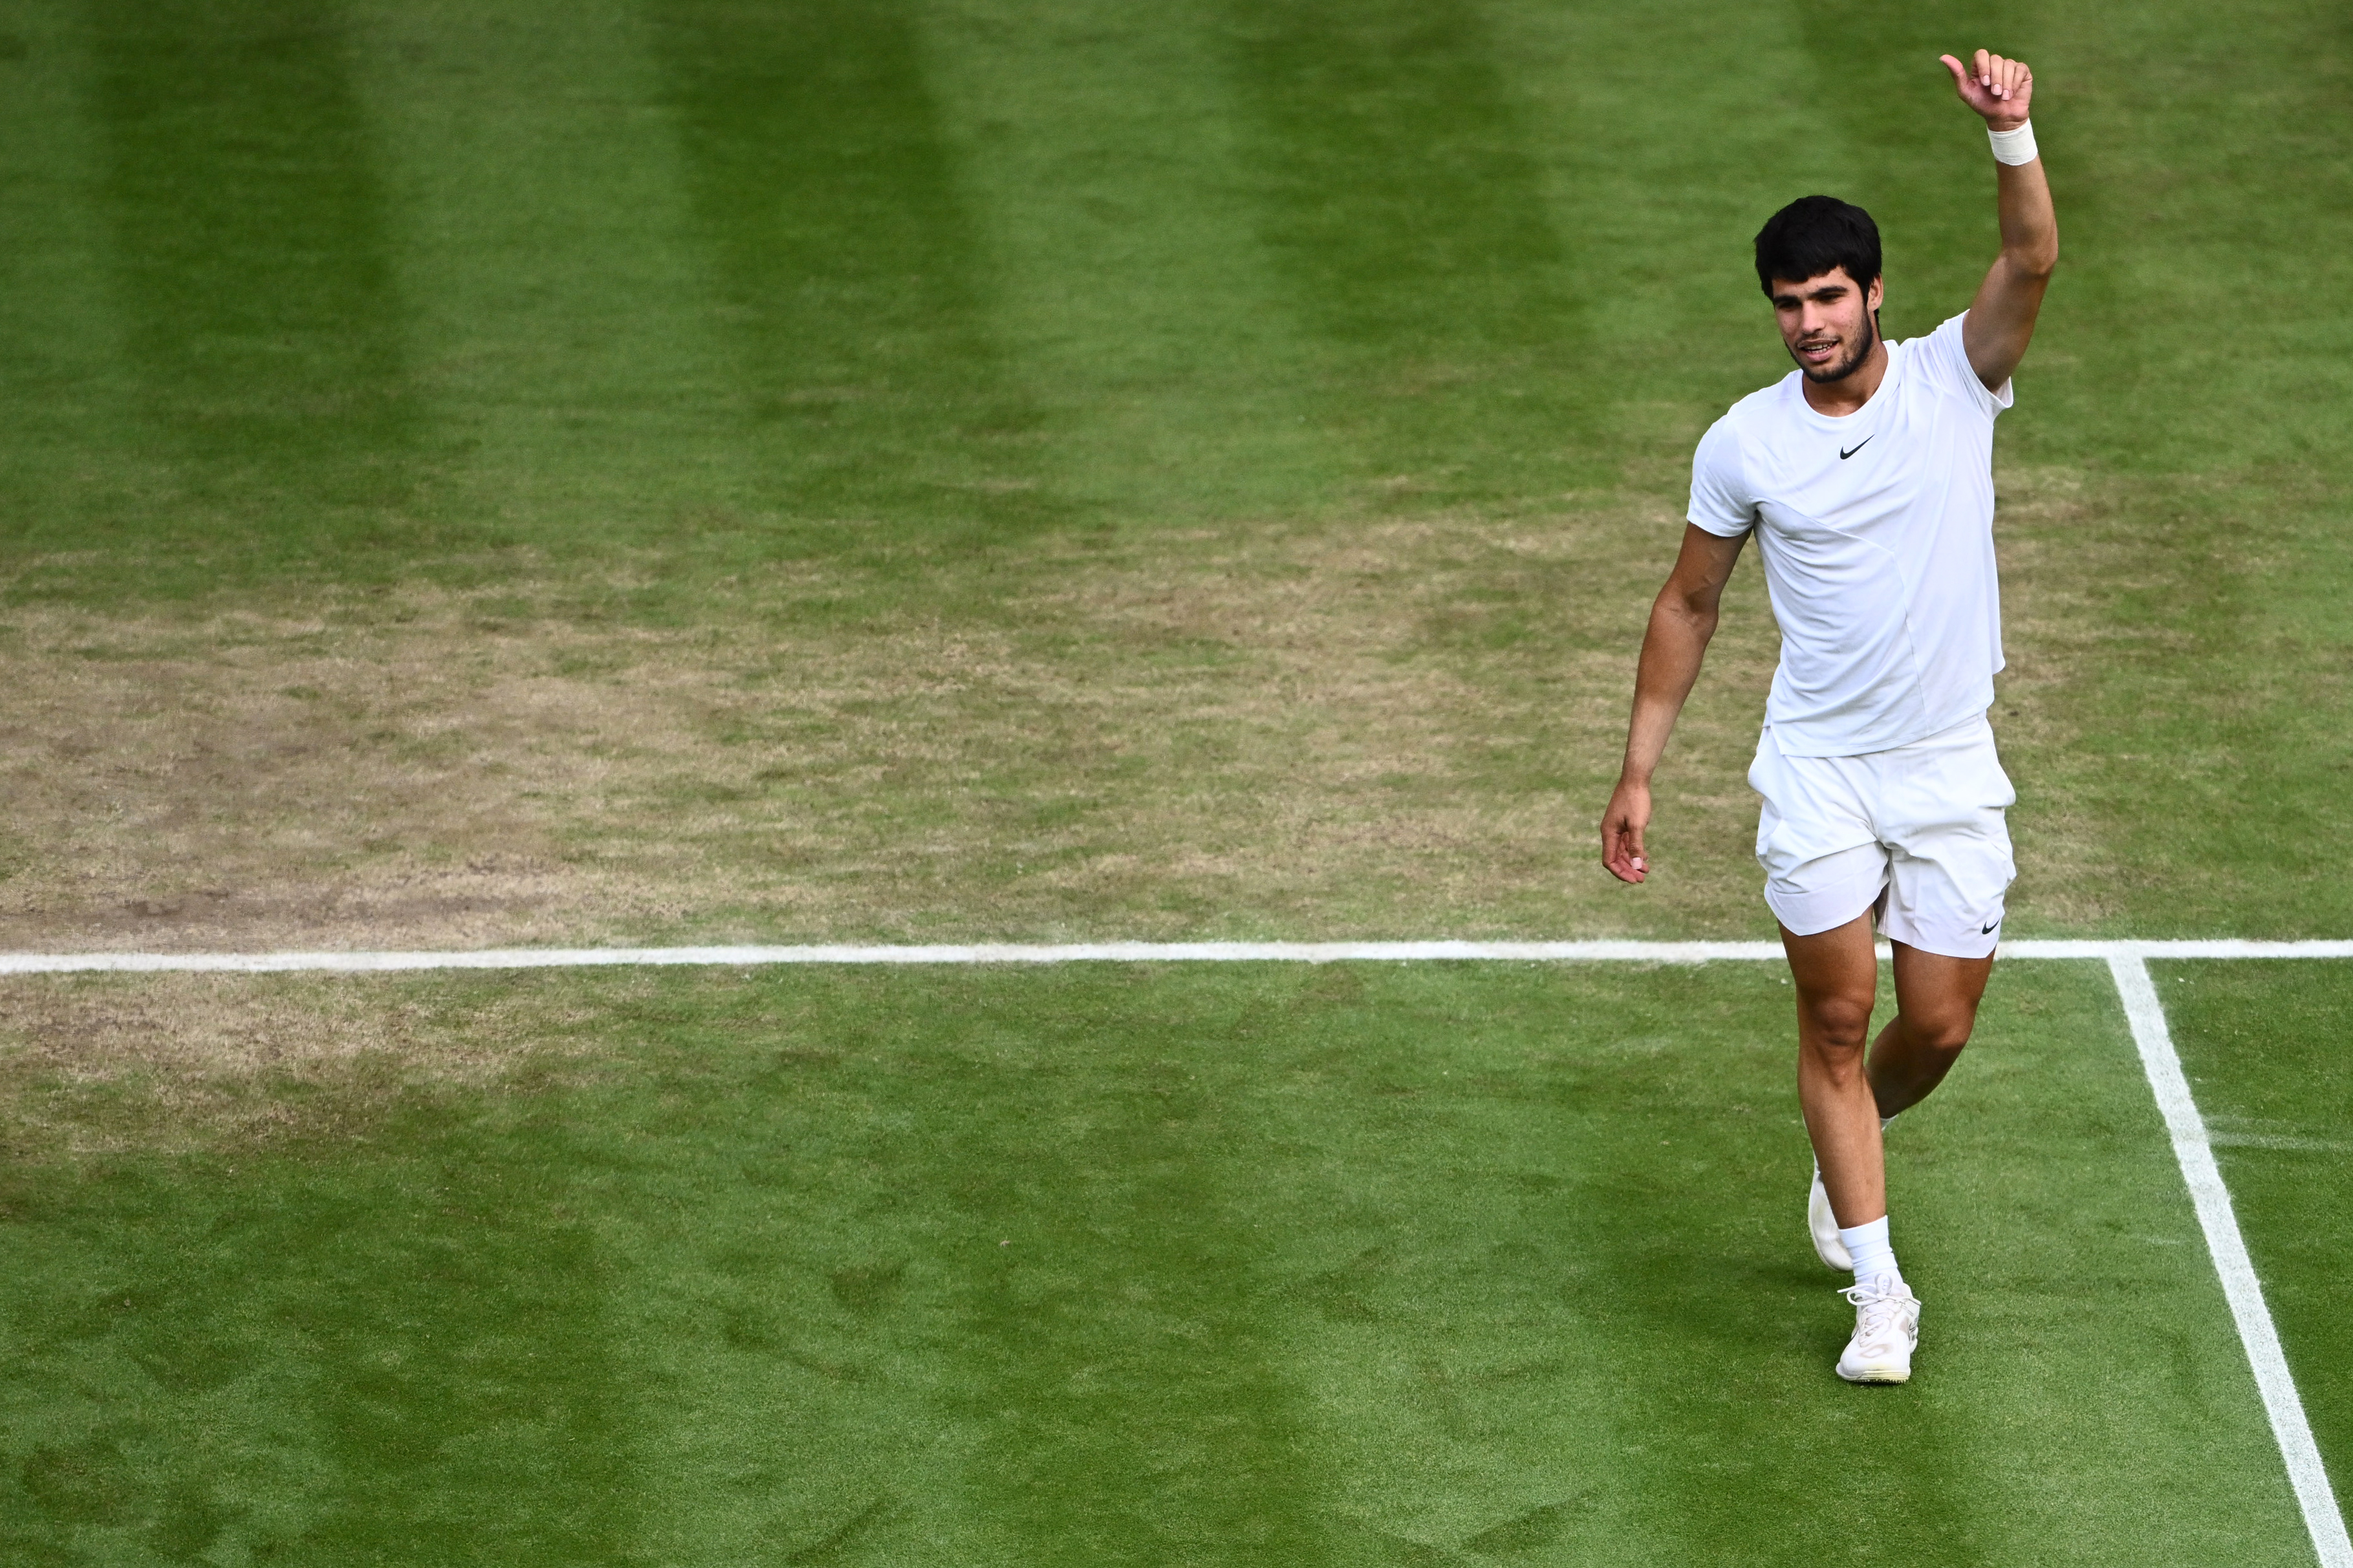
top-left (1781, 914), bottom-right (1882, 1227)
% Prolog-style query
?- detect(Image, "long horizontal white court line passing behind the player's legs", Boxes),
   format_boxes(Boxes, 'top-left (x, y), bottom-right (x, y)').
top-left (0, 940), bottom-right (2353, 976)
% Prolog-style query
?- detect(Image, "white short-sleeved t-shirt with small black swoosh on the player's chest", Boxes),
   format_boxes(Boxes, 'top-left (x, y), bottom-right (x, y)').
top-left (1689, 315), bottom-right (2010, 757)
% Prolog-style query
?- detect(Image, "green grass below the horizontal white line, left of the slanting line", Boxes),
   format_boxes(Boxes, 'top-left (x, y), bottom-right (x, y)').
top-left (0, 964), bottom-right (2306, 1563)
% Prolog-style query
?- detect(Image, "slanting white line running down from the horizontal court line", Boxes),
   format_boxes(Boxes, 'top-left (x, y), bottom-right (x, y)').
top-left (2109, 957), bottom-right (2353, 1568)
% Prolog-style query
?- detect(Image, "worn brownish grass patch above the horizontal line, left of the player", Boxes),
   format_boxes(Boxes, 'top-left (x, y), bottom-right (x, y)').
top-left (0, 508), bottom-right (1772, 950)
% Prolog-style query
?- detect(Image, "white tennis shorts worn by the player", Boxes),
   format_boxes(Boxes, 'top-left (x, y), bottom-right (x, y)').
top-left (1748, 714), bottom-right (2017, 959)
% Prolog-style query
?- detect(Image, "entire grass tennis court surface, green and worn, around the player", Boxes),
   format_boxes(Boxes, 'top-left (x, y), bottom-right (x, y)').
top-left (0, 0), bottom-right (2353, 1568)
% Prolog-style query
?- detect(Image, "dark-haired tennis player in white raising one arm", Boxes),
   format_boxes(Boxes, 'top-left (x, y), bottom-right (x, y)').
top-left (1602, 49), bottom-right (2059, 1382)
